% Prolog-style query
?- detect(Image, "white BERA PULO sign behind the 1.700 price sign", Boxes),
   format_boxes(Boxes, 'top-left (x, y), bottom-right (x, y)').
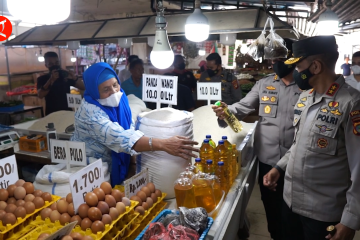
top-left (50, 139), bottom-right (87, 169)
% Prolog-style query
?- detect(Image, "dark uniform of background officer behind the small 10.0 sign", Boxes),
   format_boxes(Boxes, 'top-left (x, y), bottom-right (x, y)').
top-left (199, 69), bottom-right (242, 105)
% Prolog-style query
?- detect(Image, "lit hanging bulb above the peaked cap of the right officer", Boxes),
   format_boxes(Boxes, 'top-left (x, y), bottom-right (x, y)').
top-left (317, 0), bottom-right (339, 35)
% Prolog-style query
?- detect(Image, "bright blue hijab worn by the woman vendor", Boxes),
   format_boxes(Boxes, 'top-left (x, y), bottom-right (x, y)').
top-left (84, 62), bottom-right (132, 187)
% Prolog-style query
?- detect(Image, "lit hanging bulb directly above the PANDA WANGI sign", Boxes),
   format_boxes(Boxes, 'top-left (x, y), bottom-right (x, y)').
top-left (150, 0), bottom-right (174, 69)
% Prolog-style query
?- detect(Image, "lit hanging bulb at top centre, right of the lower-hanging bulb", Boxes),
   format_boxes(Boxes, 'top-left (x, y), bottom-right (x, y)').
top-left (185, 0), bottom-right (210, 42)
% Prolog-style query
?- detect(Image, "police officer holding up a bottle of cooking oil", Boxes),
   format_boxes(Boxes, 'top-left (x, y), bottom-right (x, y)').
top-left (213, 39), bottom-right (301, 240)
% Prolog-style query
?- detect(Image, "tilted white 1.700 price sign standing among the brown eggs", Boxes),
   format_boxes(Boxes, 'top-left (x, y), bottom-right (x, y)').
top-left (69, 159), bottom-right (104, 213)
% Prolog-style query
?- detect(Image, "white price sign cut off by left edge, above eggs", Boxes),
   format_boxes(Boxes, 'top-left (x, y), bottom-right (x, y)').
top-left (0, 155), bottom-right (19, 189)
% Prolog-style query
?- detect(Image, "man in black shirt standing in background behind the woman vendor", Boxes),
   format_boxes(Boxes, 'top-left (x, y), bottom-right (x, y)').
top-left (37, 52), bottom-right (85, 115)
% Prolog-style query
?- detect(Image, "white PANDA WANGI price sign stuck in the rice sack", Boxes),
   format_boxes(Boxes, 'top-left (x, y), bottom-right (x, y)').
top-left (142, 74), bottom-right (178, 109)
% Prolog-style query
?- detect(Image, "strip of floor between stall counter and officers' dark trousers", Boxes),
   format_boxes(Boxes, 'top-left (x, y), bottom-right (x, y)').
top-left (246, 184), bottom-right (360, 240)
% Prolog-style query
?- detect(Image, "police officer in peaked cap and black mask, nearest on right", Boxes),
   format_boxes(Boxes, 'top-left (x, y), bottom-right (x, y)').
top-left (263, 36), bottom-right (360, 240)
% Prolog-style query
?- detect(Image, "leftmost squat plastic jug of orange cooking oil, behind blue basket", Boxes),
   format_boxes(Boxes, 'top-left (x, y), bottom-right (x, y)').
top-left (174, 177), bottom-right (196, 208)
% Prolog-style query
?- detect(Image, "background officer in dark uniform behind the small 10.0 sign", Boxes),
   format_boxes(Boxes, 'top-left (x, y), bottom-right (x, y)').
top-left (199, 53), bottom-right (242, 104)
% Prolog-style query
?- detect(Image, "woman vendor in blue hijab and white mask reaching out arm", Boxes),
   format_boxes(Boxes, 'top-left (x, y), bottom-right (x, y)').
top-left (71, 63), bottom-right (198, 186)
